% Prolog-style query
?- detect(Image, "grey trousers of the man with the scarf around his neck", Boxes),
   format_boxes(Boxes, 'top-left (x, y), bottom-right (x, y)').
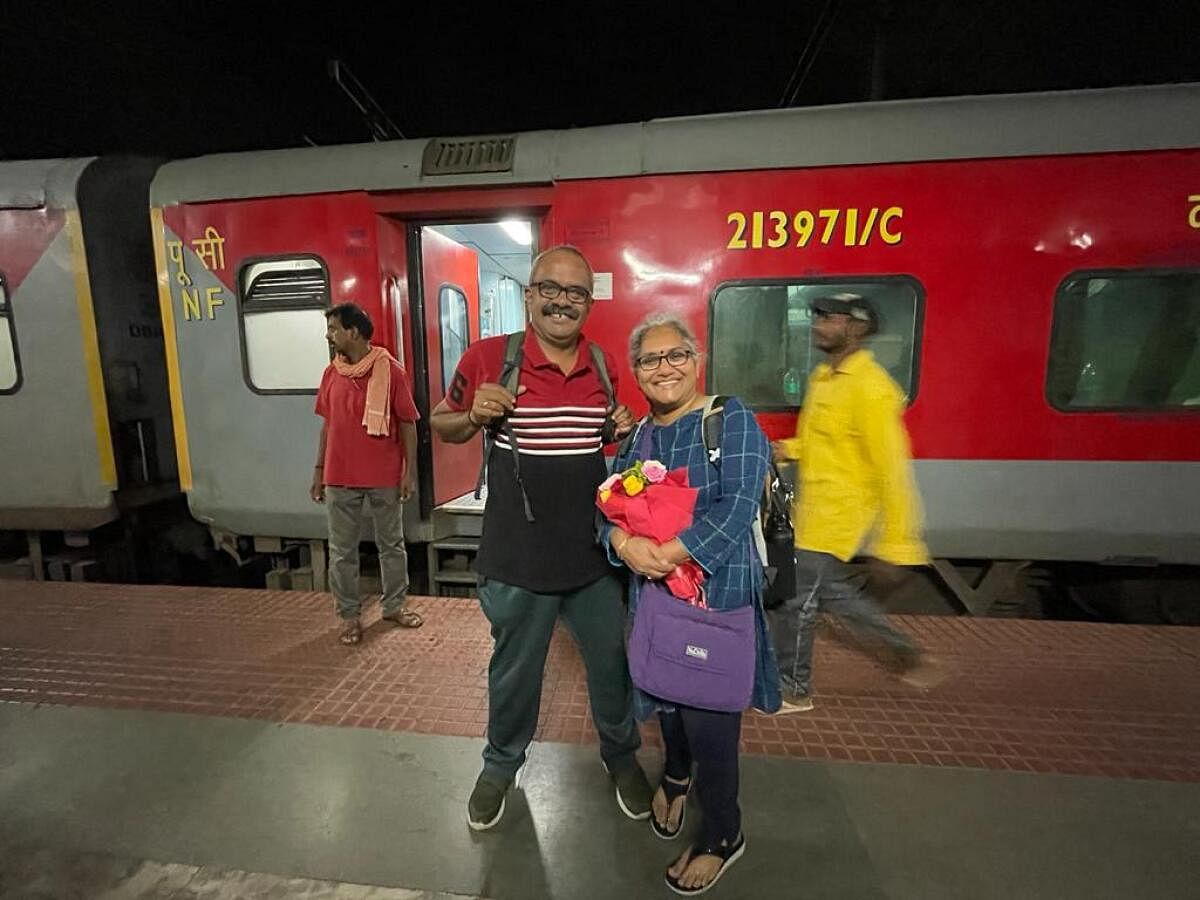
top-left (325, 487), bottom-right (408, 619)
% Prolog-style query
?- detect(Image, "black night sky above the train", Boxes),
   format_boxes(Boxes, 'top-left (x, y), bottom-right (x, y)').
top-left (0, 0), bottom-right (1200, 158)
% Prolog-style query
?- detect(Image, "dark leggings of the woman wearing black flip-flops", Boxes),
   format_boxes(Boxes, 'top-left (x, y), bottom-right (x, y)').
top-left (659, 706), bottom-right (742, 846)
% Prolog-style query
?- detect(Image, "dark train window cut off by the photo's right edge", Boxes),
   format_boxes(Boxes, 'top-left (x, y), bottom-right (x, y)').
top-left (1046, 270), bottom-right (1200, 412)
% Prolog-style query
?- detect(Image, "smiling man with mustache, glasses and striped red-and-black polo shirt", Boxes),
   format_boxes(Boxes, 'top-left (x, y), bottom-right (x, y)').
top-left (431, 246), bottom-right (650, 830)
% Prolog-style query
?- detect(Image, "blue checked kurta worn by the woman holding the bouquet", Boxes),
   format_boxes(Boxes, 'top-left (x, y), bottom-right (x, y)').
top-left (600, 397), bottom-right (780, 719)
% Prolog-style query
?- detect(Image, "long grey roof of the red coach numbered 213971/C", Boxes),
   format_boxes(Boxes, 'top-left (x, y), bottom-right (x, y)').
top-left (151, 83), bottom-right (1200, 206)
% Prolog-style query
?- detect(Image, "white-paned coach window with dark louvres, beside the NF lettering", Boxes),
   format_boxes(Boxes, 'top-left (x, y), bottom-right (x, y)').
top-left (239, 256), bottom-right (330, 394)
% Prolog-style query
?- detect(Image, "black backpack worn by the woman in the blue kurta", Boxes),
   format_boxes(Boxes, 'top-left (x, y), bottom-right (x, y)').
top-left (620, 396), bottom-right (796, 610)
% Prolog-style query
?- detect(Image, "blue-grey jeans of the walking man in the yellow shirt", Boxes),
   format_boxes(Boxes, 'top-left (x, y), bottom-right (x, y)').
top-left (768, 550), bottom-right (920, 696)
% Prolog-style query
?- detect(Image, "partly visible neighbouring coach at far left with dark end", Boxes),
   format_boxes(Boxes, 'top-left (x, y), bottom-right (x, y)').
top-left (0, 157), bottom-right (194, 581)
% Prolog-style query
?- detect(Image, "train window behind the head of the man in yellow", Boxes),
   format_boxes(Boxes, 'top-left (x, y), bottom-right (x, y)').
top-left (707, 275), bottom-right (925, 409)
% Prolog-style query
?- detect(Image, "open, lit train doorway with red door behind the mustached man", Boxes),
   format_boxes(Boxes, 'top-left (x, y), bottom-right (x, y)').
top-left (371, 185), bottom-right (553, 549)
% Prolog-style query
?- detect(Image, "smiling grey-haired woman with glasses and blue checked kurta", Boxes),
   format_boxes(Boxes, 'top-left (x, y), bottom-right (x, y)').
top-left (600, 313), bottom-right (780, 895)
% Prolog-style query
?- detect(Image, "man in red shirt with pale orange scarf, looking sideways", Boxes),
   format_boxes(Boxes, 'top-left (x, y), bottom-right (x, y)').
top-left (311, 304), bottom-right (422, 644)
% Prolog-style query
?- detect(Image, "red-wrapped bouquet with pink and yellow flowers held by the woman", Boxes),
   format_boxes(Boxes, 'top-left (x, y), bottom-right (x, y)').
top-left (596, 460), bottom-right (706, 606)
